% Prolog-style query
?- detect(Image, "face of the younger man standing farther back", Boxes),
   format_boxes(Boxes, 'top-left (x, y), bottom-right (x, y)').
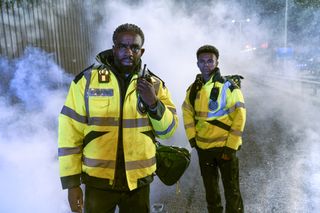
top-left (197, 53), bottom-right (218, 80)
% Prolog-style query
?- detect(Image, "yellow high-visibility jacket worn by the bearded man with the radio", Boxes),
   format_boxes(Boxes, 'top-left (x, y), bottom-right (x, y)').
top-left (58, 52), bottom-right (178, 190)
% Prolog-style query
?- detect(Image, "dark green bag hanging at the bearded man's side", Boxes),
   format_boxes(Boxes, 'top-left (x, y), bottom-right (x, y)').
top-left (156, 142), bottom-right (191, 186)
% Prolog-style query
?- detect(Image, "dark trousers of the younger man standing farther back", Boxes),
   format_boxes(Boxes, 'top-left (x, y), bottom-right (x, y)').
top-left (197, 149), bottom-right (244, 213)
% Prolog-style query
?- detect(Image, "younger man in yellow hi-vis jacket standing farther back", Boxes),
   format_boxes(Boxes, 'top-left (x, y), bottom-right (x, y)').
top-left (182, 45), bottom-right (246, 213)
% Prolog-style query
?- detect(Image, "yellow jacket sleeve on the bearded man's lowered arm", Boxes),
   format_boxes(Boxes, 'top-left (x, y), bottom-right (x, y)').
top-left (58, 77), bottom-right (87, 189)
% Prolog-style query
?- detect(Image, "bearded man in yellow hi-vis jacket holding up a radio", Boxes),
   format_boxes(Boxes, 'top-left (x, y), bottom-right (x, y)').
top-left (59, 24), bottom-right (178, 213)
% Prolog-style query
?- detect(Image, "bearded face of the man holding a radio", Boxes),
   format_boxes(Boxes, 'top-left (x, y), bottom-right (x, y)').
top-left (113, 32), bottom-right (144, 70)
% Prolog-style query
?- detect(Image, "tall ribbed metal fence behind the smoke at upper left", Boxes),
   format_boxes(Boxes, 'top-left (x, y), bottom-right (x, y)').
top-left (0, 0), bottom-right (93, 73)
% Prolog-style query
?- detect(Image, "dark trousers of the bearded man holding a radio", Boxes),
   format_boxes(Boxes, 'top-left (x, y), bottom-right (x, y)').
top-left (84, 185), bottom-right (150, 213)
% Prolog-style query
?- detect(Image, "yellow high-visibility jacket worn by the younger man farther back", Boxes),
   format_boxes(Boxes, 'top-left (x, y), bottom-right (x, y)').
top-left (182, 70), bottom-right (246, 152)
